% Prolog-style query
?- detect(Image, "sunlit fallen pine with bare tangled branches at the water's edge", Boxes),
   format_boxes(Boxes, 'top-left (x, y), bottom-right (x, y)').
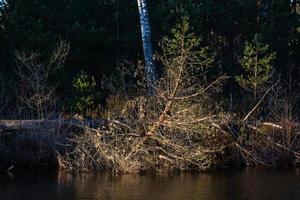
top-left (59, 20), bottom-right (231, 172)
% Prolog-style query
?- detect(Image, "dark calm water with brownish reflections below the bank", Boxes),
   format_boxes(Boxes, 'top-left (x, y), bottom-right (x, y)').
top-left (0, 169), bottom-right (300, 200)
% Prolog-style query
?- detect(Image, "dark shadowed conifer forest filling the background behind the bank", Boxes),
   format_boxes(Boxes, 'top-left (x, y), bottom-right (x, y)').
top-left (0, 0), bottom-right (300, 116)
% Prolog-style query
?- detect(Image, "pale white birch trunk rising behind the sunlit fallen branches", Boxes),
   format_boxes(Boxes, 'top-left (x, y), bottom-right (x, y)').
top-left (137, 0), bottom-right (157, 96)
